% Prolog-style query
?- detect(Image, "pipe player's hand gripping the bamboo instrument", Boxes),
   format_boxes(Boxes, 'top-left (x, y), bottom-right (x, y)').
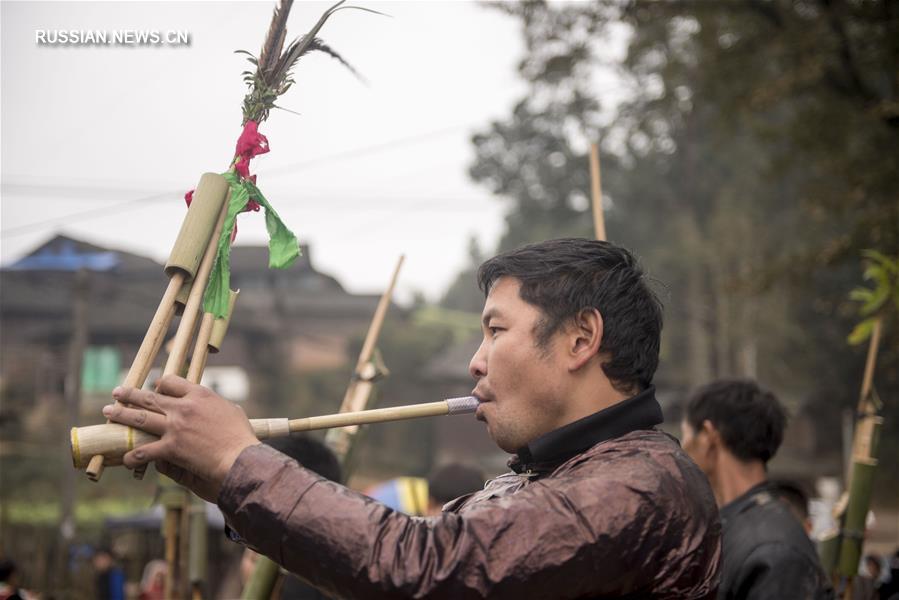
top-left (103, 375), bottom-right (259, 502)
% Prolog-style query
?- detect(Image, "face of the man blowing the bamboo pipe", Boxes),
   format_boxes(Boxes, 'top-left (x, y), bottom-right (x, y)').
top-left (468, 277), bottom-right (568, 453)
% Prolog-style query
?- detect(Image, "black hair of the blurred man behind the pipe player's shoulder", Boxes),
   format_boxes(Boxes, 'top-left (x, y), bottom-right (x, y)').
top-left (687, 379), bottom-right (787, 463)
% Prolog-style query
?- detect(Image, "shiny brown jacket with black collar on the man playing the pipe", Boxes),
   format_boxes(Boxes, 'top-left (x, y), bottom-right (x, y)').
top-left (219, 387), bottom-right (721, 599)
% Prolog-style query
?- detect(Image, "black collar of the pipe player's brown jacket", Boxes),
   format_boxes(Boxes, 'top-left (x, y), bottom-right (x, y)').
top-left (509, 386), bottom-right (663, 473)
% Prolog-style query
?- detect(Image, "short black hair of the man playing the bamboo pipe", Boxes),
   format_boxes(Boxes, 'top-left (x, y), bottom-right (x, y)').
top-left (478, 238), bottom-right (662, 392)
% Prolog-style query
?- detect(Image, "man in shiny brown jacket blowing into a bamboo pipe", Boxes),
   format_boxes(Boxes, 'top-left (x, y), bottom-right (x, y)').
top-left (104, 239), bottom-right (720, 599)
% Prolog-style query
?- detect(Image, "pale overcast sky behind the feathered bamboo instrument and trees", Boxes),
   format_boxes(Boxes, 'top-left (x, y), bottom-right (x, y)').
top-left (0, 0), bottom-right (525, 300)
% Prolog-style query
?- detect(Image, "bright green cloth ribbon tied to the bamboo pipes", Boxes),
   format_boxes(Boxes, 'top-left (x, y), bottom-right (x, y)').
top-left (203, 171), bottom-right (300, 319)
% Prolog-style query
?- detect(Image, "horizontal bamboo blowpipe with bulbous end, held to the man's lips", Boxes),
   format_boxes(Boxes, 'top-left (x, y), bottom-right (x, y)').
top-left (70, 396), bottom-right (478, 469)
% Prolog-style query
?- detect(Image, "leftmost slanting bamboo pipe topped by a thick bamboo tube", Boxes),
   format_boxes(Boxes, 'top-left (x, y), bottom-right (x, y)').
top-left (86, 173), bottom-right (228, 481)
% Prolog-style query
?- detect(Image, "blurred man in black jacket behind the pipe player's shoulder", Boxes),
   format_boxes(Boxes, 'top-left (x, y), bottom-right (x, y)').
top-left (681, 380), bottom-right (833, 600)
